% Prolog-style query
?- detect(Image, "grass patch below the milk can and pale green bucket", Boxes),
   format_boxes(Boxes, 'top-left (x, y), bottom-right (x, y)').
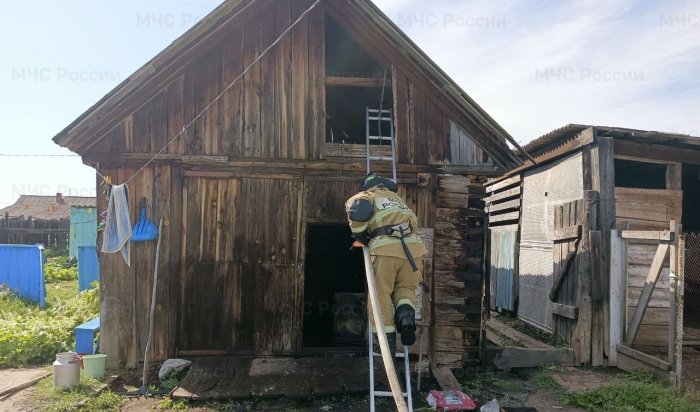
top-left (32, 375), bottom-right (126, 412)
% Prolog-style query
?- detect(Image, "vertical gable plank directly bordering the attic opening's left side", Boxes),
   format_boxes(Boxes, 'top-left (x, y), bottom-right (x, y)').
top-left (307, 3), bottom-right (326, 159)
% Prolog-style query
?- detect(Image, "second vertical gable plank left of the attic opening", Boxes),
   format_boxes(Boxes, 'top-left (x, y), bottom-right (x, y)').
top-left (291, 0), bottom-right (310, 159)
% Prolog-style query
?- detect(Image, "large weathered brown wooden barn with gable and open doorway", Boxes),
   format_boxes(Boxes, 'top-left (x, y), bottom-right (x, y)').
top-left (54, 0), bottom-right (520, 374)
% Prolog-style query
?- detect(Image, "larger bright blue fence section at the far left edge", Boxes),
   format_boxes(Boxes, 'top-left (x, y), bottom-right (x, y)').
top-left (0, 245), bottom-right (46, 308)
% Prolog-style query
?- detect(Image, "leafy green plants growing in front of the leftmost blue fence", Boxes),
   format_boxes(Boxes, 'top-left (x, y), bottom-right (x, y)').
top-left (0, 281), bottom-right (99, 368)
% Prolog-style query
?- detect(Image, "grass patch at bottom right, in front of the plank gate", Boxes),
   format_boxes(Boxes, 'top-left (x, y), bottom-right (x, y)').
top-left (564, 372), bottom-right (700, 412)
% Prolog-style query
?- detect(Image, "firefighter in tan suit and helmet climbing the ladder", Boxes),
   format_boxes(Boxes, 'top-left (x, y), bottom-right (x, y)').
top-left (345, 173), bottom-right (428, 353)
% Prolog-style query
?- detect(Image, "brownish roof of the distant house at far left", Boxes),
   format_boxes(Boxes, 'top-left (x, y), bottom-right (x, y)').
top-left (0, 195), bottom-right (97, 220)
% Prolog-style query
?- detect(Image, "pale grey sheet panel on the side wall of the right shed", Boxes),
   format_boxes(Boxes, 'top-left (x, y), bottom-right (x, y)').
top-left (518, 153), bottom-right (583, 331)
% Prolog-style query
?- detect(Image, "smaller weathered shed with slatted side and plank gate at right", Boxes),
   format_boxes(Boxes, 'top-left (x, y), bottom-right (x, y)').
top-left (486, 124), bottom-right (700, 384)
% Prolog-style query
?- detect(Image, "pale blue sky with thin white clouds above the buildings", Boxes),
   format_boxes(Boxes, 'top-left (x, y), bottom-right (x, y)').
top-left (0, 0), bottom-right (700, 207)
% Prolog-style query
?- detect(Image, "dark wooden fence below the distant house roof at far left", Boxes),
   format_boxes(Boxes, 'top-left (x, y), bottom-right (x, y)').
top-left (0, 216), bottom-right (70, 249)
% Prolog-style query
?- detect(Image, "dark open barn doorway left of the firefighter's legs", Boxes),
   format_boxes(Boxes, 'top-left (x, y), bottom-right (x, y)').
top-left (303, 224), bottom-right (367, 348)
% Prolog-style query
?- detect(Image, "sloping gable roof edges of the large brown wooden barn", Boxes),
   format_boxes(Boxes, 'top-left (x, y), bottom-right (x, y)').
top-left (53, 0), bottom-right (522, 170)
